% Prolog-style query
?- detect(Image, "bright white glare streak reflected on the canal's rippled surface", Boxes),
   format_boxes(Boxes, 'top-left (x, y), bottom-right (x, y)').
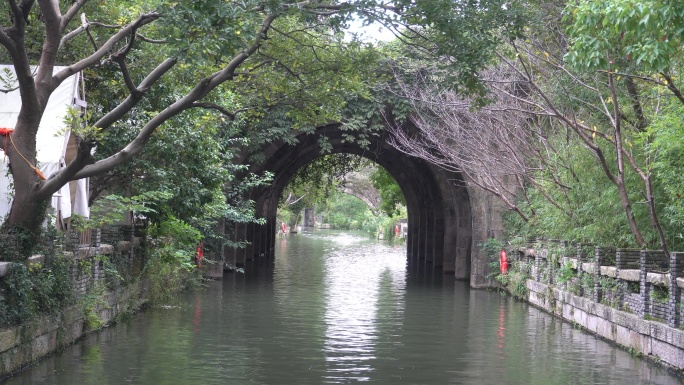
top-left (324, 230), bottom-right (406, 383)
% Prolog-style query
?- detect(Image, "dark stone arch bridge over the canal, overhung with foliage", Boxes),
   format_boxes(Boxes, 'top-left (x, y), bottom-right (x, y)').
top-left (224, 121), bottom-right (505, 288)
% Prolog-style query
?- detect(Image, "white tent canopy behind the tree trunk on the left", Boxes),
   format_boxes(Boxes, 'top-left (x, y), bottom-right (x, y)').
top-left (0, 65), bottom-right (90, 228)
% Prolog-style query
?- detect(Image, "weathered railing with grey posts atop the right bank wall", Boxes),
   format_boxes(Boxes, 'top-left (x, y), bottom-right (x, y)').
top-left (508, 239), bottom-right (684, 328)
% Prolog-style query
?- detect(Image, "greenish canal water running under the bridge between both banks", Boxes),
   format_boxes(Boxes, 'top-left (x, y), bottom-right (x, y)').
top-left (6, 230), bottom-right (683, 385)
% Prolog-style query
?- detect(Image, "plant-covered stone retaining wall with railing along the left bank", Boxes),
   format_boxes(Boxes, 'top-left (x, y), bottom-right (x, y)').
top-left (0, 226), bottom-right (148, 379)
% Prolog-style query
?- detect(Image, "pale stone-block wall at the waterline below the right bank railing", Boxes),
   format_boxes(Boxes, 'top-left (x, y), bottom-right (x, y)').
top-left (526, 280), bottom-right (684, 373)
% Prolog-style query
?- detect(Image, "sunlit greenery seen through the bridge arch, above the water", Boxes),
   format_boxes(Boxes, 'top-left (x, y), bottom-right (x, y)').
top-left (276, 153), bottom-right (407, 232)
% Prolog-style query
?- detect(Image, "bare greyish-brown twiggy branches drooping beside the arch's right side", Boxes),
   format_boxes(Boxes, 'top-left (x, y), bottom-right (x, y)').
top-left (387, 63), bottom-right (572, 221)
